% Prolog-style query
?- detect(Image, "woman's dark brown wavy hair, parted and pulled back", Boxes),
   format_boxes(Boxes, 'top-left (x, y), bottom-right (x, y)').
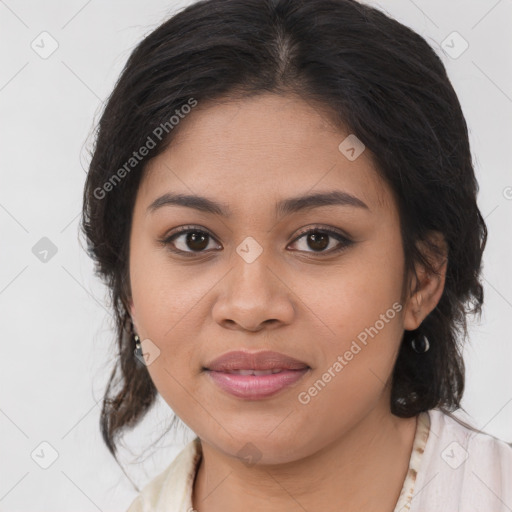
top-left (81, 0), bottom-right (487, 476)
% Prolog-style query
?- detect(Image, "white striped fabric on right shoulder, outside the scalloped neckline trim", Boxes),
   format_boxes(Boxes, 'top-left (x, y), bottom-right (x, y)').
top-left (411, 409), bottom-right (512, 512)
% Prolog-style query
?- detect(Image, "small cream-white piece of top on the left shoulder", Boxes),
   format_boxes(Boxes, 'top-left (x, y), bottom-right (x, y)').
top-left (126, 437), bottom-right (202, 512)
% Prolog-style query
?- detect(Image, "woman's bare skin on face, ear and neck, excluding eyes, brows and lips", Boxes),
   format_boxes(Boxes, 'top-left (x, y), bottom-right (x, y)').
top-left (130, 93), bottom-right (446, 512)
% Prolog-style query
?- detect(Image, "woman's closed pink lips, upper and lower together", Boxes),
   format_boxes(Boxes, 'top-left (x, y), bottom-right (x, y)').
top-left (205, 351), bottom-right (310, 400)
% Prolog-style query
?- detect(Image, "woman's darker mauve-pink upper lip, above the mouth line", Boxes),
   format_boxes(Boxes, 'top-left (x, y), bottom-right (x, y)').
top-left (205, 350), bottom-right (309, 372)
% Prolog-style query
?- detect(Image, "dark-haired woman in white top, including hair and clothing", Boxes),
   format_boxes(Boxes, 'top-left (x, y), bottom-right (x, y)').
top-left (82, 0), bottom-right (512, 512)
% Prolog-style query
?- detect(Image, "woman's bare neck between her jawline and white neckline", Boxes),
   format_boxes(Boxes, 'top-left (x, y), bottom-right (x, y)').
top-left (192, 409), bottom-right (417, 512)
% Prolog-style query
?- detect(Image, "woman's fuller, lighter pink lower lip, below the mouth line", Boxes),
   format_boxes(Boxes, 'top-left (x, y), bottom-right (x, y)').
top-left (207, 368), bottom-right (309, 400)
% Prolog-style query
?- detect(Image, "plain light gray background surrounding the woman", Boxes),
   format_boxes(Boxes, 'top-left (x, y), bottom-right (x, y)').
top-left (0, 0), bottom-right (512, 512)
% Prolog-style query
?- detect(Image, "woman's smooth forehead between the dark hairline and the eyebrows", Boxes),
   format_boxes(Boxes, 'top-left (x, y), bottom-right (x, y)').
top-left (139, 94), bottom-right (394, 215)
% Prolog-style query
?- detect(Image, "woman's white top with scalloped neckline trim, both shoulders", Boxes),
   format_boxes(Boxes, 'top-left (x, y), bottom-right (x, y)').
top-left (127, 409), bottom-right (512, 512)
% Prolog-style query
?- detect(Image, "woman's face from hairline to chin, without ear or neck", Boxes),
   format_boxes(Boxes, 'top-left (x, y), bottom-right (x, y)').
top-left (130, 94), bottom-right (422, 463)
